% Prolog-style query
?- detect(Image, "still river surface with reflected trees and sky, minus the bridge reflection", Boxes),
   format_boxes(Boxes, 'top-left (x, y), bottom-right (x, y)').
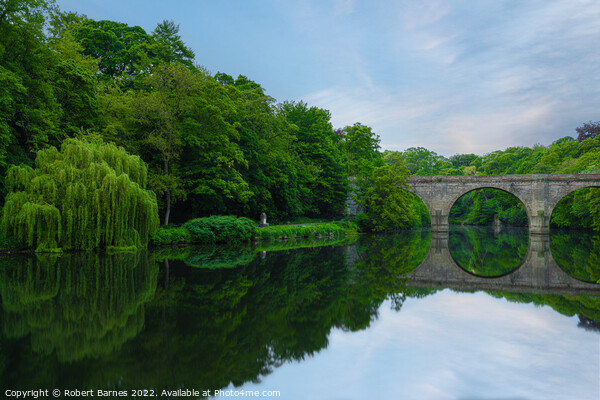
top-left (0, 228), bottom-right (600, 400)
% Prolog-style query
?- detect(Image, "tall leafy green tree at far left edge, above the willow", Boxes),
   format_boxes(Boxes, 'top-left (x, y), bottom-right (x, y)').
top-left (0, 4), bottom-right (99, 203)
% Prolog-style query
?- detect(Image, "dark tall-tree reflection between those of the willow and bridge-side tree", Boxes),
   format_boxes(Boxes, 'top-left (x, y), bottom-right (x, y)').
top-left (107, 248), bottom-right (348, 390)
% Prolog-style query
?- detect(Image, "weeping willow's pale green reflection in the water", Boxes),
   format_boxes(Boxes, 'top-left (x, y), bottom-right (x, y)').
top-left (0, 253), bottom-right (158, 386)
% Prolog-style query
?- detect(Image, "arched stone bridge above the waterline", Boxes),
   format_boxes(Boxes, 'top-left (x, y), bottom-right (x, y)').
top-left (407, 174), bottom-right (600, 234)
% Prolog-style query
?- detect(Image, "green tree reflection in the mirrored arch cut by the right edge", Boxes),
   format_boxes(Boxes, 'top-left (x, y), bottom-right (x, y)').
top-left (550, 231), bottom-right (600, 282)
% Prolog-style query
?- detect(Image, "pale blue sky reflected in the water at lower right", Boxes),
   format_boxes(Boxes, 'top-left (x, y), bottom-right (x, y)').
top-left (218, 289), bottom-right (600, 400)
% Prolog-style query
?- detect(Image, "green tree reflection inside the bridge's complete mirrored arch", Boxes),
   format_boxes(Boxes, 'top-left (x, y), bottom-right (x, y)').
top-left (448, 227), bottom-right (529, 277)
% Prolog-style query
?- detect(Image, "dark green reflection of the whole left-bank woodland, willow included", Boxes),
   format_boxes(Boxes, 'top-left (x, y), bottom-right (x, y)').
top-left (0, 232), bottom-right (429, 391)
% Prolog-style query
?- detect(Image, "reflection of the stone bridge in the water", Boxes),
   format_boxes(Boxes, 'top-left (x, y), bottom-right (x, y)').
top-left (407, 231), bottom-right (600, 295)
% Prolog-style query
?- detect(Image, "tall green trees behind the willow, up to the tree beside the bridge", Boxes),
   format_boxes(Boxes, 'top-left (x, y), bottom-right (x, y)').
top-left (0, 0), bottom-right (370, 231)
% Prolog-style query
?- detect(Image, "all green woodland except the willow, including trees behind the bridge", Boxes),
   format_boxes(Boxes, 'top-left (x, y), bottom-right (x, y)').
top-left (0, 0), bottom-right (600, 244)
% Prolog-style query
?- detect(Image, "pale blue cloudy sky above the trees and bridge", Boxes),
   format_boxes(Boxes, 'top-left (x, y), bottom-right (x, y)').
top-left (56, 0), bottom-right (600, 156)
